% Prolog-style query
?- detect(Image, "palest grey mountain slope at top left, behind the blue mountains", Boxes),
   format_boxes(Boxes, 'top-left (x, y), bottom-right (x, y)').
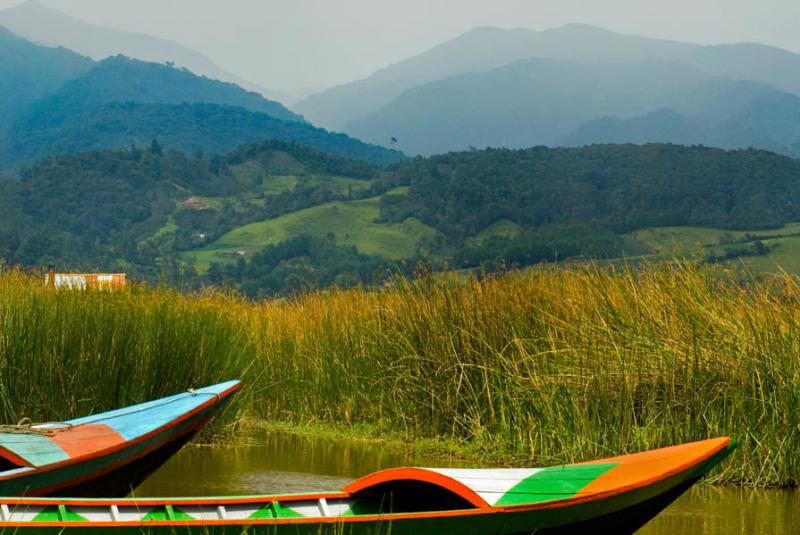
top-left (0, 0), bottom-right (284, 100)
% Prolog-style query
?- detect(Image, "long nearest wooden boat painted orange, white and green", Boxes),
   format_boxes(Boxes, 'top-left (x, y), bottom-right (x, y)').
top-left (0, 438), bottom-right (734, 535)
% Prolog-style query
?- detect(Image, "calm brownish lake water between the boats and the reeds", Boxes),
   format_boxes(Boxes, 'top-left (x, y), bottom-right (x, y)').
top-left (136, 433), bottom-right (800, 535)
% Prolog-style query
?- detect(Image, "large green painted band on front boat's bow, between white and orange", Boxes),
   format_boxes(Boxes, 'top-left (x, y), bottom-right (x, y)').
top-left (496, 463), bottom-right (619, 505)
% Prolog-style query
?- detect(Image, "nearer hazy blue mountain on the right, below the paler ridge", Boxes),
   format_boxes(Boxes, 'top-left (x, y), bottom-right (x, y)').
top-left (349, 59), bottom-right (800, 155)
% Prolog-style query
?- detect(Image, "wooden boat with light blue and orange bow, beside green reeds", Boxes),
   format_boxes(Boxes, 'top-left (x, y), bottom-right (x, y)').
top-left (0, 381), bottom-right (240, 497)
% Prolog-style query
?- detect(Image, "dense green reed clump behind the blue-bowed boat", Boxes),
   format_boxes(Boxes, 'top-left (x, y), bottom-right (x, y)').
top-left (0, 271), bottom-right (253, 432)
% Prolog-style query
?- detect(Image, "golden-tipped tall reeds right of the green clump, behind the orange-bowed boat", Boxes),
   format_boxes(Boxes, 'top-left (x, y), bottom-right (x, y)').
top-left (251, 264), bottom-right (800, 485)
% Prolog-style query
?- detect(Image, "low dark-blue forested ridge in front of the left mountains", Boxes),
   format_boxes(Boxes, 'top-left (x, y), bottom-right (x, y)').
top-left (0, 102), bottom-right (403, 166)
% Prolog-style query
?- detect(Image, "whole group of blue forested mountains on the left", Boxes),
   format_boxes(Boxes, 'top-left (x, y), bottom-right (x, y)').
top-left (0, 28), bottom-right (403, 168)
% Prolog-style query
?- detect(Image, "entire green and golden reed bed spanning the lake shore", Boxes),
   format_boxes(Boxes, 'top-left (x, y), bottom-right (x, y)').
top-left (0, 263), bottom-right (800, 486)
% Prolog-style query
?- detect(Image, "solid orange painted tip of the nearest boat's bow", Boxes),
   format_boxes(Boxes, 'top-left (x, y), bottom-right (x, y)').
top-left (579, 438), bottom-right (730, 495)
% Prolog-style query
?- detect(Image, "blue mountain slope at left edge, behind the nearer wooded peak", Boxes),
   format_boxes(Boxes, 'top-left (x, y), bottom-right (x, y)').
top-left (0, 26), bottom-right (92, 137)
